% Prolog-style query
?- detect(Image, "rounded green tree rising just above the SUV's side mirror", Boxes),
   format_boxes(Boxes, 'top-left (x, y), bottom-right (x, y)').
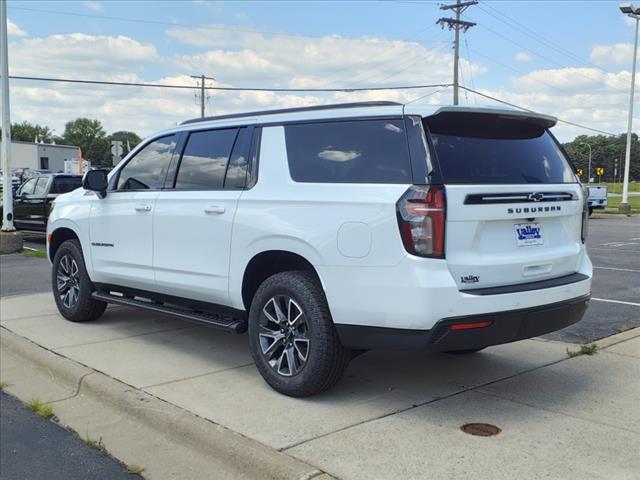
top-left (62, 118), bottom-right (111, 165)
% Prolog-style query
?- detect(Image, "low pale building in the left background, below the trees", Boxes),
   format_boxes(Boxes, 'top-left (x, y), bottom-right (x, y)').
top-left (0, 140), bottom-right (78, 172)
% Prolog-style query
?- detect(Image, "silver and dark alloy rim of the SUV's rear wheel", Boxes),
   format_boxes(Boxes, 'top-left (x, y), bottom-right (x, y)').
top-left (258, 295), bottom-right (310, 377)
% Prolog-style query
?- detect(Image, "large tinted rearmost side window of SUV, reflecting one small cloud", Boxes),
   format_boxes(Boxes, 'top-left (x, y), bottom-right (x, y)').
top-left (285, 120), bottom-right (411, 183)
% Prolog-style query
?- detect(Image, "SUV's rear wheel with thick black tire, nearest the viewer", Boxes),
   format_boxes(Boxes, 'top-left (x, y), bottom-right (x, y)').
top-left (249, 271), bottom-right (351, 397)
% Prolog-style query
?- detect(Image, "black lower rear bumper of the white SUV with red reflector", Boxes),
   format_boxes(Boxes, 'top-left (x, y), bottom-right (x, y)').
top-left (336, 295), bottom-right (590, 351)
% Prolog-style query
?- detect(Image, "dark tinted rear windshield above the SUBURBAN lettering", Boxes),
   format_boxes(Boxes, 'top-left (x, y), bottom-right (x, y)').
top-left (425, 113), bottom-right (577, 184)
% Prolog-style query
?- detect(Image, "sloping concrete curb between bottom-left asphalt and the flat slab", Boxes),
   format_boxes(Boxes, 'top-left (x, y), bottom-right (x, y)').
top-left (0, 328), bottom-right (330, 479)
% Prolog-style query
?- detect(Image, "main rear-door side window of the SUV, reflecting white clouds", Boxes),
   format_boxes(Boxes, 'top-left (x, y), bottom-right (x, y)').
top-left (176, 129), bottom-right (238, 190)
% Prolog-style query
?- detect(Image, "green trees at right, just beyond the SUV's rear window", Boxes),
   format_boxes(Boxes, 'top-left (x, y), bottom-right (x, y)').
top-left (563, 133), bottom-right (640, 182)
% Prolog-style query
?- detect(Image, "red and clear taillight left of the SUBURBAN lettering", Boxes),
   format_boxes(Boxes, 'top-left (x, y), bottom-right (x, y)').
top-left (396, 185), bottom-right (446, 258)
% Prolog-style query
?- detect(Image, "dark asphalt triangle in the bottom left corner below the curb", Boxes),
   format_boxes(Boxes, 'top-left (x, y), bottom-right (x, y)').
top-left (0, 392), bottom-right (142, 480)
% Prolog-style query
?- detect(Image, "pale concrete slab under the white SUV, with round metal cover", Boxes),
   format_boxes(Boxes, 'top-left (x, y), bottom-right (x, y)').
top-left (0, 294), bottom-right (640, 479)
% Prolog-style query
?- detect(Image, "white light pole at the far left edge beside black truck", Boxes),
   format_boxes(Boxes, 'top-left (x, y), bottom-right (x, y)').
top-left (0, 0), bottom-right (15, 232)
